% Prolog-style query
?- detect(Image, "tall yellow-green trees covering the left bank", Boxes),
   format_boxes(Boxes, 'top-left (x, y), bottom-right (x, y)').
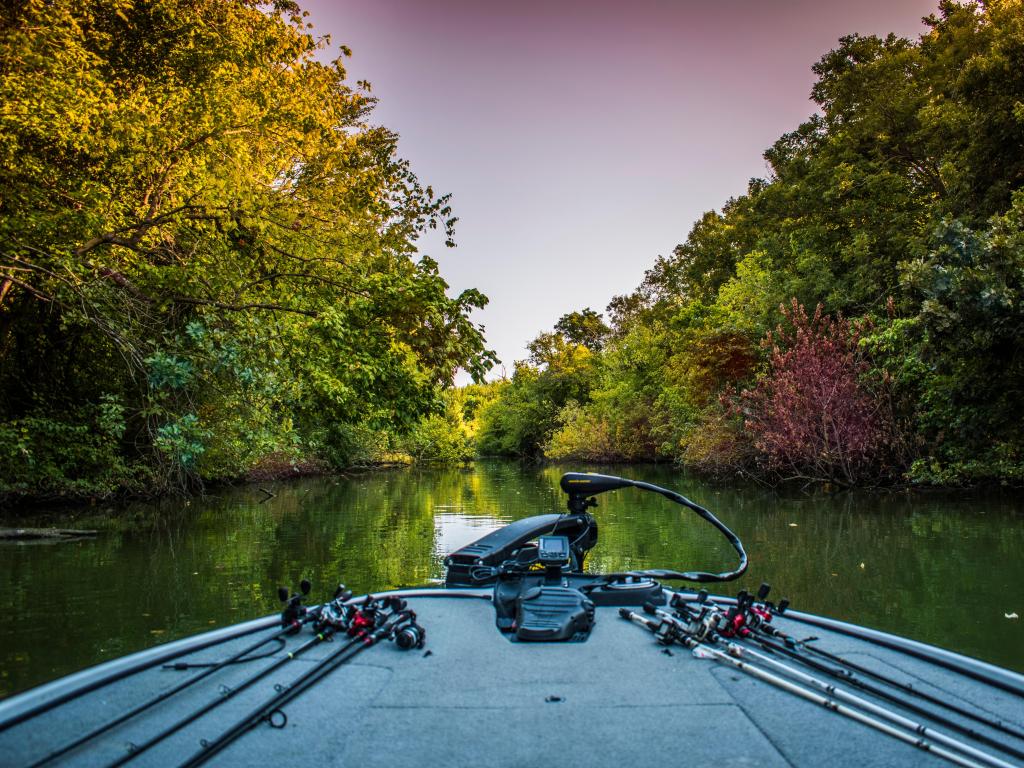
top-left (0, 0), bottom-right (494, 501)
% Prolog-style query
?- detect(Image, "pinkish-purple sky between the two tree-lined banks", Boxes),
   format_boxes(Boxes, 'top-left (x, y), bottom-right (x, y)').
top-left (300, 0), bottom-right (937, 383)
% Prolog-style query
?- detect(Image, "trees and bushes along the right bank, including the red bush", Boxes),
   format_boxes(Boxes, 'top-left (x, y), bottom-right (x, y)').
top-left (469, 0), bottom-right (1024, 484)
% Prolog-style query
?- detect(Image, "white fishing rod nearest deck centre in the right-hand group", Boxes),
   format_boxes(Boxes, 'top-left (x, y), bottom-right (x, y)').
top-left (618, 608), bottom-right (995, 768)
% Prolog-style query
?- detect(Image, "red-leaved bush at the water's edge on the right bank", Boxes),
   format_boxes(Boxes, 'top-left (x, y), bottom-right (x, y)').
top-left (740, 299), bottom-right (893, 485)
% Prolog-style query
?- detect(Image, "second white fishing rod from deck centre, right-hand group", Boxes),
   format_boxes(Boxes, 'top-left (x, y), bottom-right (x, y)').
top-left (644, 603), bottom-right (1014, 768)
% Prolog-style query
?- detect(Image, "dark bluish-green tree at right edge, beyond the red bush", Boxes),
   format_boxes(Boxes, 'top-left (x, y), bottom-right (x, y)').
top-left (904, 199), bottom-right (1024, 482)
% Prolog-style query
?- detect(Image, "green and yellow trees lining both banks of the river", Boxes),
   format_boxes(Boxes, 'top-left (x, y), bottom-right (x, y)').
top-left (0, 0), bottom-right (1024, 502)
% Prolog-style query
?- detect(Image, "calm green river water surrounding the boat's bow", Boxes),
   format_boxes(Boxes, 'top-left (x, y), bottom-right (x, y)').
top-left (0, 462), bottom-right (1024, 695)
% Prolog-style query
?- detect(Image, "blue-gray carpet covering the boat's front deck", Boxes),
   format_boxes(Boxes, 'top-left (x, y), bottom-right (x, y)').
top-left (0, 598), bottom-right (1024, 768)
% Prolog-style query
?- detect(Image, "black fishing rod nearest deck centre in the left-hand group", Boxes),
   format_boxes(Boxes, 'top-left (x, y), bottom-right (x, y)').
top-left (179, 599), bottom-right (426, 768)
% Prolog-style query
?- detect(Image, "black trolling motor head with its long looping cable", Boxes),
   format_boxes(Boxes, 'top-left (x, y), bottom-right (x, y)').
top-left (560, 472), bottom-right (746, 583)
